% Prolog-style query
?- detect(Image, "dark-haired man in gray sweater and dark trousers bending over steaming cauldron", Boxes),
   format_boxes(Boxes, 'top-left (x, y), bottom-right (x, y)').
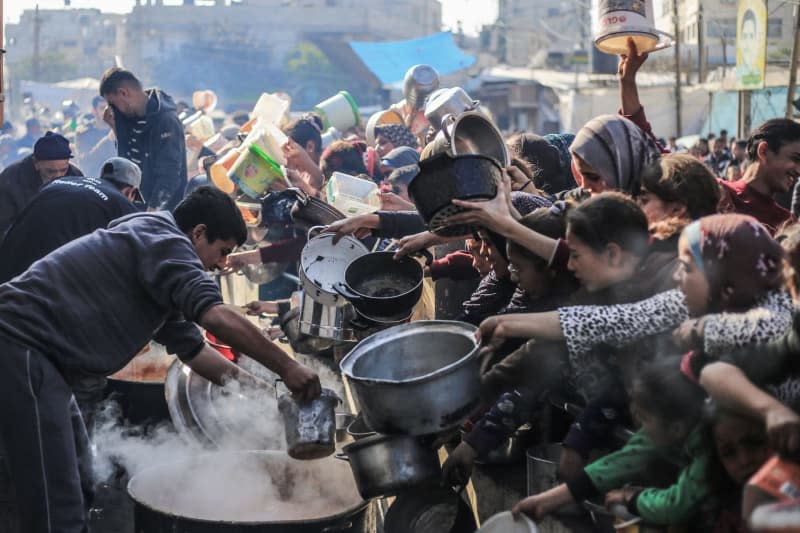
top-left (0, 187), bottom-right (321, 533)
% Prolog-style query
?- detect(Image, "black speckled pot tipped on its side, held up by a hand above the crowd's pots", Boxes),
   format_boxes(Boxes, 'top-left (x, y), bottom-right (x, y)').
top-left (408, 153), bottom-right (503, 237)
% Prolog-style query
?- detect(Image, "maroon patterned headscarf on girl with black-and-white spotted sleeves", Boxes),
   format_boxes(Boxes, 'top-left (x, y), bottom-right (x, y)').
top-left (682, 214), bottom-right (784, 310)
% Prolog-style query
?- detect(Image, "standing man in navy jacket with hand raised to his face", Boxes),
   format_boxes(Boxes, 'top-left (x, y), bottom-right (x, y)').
top-left (100, 67), bottom-right (188, 211)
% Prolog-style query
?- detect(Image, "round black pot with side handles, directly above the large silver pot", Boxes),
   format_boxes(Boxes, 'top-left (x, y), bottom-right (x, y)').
top-left (333, 250), bottom-right (433, 317)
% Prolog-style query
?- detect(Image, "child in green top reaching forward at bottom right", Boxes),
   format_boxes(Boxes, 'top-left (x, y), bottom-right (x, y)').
top-left (512, 357), bottom-right (712, 525)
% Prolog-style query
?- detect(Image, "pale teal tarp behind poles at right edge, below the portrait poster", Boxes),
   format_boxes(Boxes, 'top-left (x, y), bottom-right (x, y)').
top-left (700, 87), bottom-right (800, 135)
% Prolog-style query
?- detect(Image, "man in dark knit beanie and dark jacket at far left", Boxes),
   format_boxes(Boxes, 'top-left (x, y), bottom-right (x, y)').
top-left (0, 131), bottom-right (83, 240)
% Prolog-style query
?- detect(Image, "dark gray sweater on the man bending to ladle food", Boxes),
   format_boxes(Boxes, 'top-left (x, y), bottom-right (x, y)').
top-left (0, 212), bottom-right (222, 381)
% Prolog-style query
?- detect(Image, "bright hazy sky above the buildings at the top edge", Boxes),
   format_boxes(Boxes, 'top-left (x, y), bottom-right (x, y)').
top-left (3, 0), bottom-right (497, 34)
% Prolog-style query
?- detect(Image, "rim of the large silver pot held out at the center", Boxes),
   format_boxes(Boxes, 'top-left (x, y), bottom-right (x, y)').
top-left (339, 320), bottom-right (480, 385)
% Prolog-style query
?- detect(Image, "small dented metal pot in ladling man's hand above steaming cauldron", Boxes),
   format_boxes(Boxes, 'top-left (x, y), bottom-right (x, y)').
top-left (278, 389), bottom-right (342, 460)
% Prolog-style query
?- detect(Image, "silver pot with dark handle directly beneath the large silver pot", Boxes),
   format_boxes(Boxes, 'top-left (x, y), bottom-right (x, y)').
top-left (336, 435), bottom-right (442, 500)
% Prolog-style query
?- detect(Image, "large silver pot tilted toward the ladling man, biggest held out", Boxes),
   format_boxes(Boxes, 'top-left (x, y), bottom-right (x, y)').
top-left (340, 320), bottom-right (480, 435)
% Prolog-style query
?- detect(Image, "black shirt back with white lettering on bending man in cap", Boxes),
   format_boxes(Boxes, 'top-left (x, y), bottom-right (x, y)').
top-left (0, 177), bottom-right (137, 283)
